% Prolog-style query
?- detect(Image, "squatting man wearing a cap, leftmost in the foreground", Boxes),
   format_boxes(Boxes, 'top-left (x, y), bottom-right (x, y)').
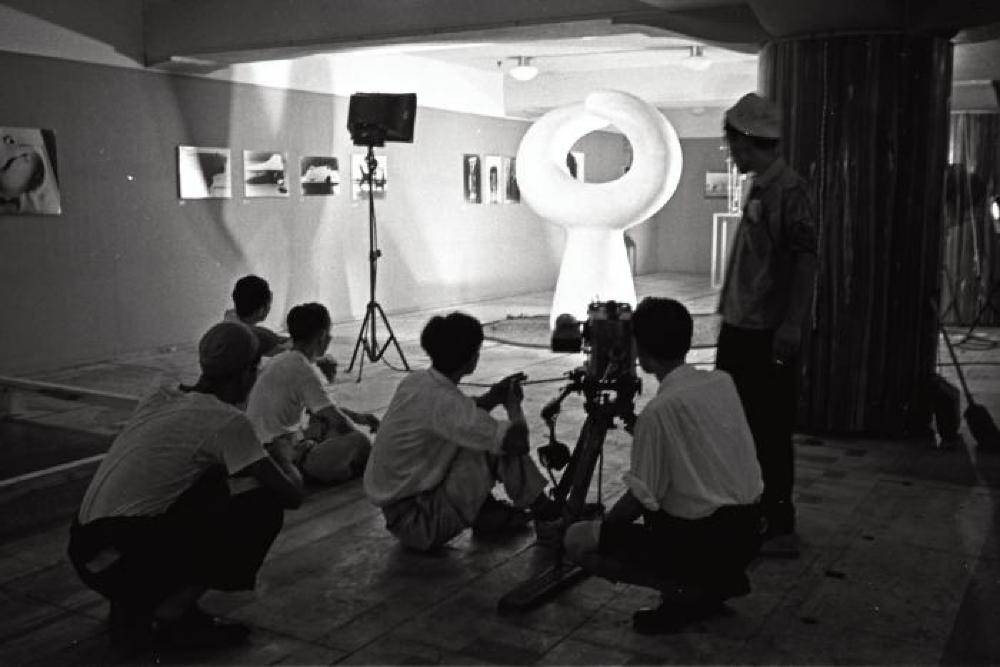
top-left (68, 322), bottom-right (302, 650)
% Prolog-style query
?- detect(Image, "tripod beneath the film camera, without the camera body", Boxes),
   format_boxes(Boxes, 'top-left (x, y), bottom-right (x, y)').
top-left (497, 368), bottom-right (639, 613)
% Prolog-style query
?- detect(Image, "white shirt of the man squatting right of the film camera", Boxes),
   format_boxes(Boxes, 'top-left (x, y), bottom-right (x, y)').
top-left (625, 364), bottom-right (764, 519)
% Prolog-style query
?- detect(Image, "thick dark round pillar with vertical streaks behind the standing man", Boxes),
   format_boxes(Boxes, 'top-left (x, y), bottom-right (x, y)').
top-left (760, 33), bottom-right (952, 436)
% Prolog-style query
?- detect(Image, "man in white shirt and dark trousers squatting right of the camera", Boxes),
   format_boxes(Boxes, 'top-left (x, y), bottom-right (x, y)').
top-left (564, 298), bottom-right (763, 633)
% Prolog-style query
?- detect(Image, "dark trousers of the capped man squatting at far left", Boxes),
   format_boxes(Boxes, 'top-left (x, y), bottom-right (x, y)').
top-left (68, 468), bottom-right (284, 613)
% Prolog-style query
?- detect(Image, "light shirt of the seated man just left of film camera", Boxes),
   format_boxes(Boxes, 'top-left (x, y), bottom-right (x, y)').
top-left (364, 368), bottom-right (510, 506)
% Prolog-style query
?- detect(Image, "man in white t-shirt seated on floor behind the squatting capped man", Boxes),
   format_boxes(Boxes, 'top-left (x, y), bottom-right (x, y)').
top-left (247, 303), bottom-right (379, 483)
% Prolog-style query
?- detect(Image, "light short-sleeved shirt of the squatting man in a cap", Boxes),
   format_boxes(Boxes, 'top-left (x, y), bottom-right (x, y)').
top-left (79, 385), bottom-right (267, 524)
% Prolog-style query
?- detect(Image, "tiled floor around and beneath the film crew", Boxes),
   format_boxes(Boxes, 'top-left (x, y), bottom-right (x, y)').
top-left (0, 275), bottom-right (1000, 665)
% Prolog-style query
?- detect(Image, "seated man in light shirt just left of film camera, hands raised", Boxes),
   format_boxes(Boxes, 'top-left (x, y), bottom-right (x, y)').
top-left (365, 313), bottom-right (548, 551)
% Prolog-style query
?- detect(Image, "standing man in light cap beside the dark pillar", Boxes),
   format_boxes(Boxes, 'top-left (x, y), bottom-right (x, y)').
top-left (716, 93), bottom-right (817, 557)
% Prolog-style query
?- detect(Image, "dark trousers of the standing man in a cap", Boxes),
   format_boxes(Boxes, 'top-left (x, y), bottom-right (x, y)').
top-left (715, 324), bottom-right (798, 532)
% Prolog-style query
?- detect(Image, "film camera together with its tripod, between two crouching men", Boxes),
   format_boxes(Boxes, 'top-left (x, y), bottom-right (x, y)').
top-left (498, 301), bottom-right (640, 612)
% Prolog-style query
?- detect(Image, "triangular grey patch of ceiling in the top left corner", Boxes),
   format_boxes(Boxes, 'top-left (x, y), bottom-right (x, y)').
top-left (3, 0), bottom-right (144, 64)
